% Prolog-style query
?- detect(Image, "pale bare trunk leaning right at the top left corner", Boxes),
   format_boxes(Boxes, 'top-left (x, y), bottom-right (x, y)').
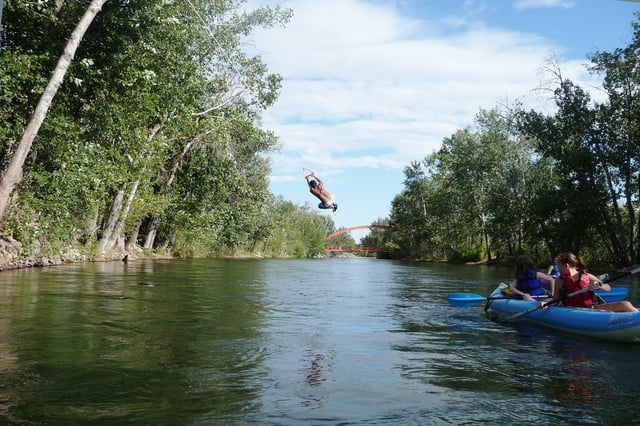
top-left (0, 0), bottom-right (107, 219)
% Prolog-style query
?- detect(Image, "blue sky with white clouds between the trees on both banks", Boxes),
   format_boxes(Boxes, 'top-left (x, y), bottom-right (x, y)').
top-left (247, 0), bottom-right (640, 241)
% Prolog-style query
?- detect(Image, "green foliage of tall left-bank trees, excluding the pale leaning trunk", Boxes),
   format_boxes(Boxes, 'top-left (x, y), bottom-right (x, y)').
top-left (0, 0), bottom-right (300, 256)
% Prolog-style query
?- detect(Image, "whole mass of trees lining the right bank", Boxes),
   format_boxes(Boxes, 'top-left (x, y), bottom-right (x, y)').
top-left (384, 16), bottom-right (640, 266)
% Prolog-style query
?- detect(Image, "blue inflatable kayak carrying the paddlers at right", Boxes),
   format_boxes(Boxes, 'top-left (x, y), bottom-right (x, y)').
top-left (487, 284), bottom-right (640, 343)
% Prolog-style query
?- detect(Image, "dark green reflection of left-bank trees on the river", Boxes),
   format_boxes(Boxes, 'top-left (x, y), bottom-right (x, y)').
top-left (0, 262), bottom-right (272, 423)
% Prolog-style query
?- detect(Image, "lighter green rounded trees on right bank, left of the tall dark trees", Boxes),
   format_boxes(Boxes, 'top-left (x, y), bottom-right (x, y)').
top-left (380, 100), bottom-right (620, 262)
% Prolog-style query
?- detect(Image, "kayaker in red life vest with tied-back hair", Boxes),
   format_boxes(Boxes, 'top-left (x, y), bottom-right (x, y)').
top-left (554, 253), bottom-right (638, 312)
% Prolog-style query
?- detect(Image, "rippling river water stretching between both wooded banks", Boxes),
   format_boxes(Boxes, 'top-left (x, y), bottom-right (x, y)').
top-left (0, 258), bottom-right (640, 425)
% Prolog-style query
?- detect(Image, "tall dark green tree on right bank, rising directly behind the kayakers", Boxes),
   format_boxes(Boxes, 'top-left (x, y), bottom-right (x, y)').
top-left (520, 61), bottom-right (630, 264)
